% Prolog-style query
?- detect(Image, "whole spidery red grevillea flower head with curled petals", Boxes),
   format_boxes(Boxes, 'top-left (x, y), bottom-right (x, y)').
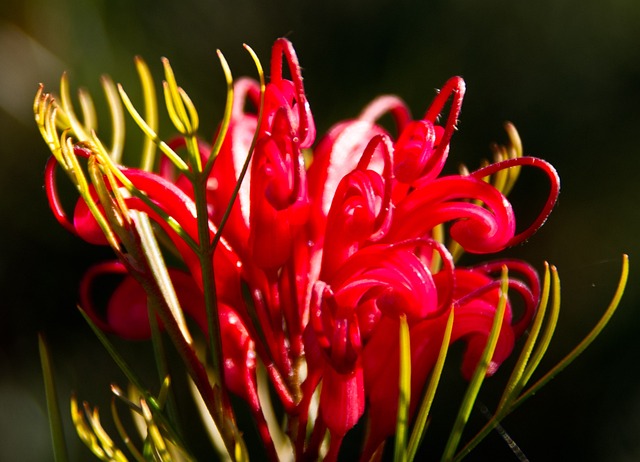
top-left (37, 39), bottom-right (559, 460)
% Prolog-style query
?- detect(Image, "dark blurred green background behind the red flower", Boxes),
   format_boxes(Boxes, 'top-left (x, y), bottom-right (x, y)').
top-left (0, 0), bottom-right (640, 461)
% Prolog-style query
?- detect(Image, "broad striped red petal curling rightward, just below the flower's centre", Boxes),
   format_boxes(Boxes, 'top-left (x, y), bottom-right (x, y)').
top-left (309, 240), bottom-right (454, 373)
